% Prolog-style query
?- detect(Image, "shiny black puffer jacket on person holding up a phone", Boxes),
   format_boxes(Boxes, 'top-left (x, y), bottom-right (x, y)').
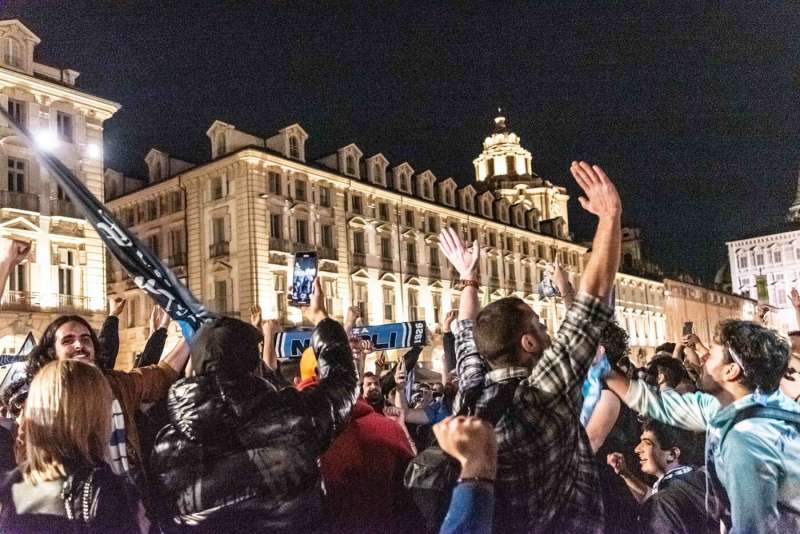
top-left (151, 319), bottom-right (358, 532)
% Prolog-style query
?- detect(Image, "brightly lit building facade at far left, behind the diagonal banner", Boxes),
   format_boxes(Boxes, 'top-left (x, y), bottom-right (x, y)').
top-left (0, 20), bottom-right (119, 354)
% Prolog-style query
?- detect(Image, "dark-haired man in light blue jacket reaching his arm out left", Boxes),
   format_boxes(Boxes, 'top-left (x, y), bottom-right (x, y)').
top-left (606, 321), bottom-right (800, 533)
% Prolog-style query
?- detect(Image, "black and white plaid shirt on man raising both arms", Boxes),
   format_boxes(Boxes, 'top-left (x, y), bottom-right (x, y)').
top-left (453, 293), bottom-right (612, 534)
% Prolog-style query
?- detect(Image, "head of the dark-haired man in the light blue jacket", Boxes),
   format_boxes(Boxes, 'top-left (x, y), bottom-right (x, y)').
top-left (700, 320), bottom-right (789, 398)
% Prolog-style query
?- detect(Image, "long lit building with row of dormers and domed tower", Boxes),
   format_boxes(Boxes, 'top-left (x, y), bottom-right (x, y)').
top-left (106, 117), bottom-right (586, 365)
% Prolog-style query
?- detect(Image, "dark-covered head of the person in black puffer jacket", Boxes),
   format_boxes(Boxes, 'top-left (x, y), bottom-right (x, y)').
top-left (191, 317), bottom-right (264, 379)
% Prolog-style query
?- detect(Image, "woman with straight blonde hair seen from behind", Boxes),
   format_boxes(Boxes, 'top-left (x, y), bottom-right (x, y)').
top-left (0, 360), bottom-right (139, 533)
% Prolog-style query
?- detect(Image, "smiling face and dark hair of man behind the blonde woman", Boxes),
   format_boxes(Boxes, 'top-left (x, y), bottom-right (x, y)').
top-left (27, 315), bottom-right (101, 376)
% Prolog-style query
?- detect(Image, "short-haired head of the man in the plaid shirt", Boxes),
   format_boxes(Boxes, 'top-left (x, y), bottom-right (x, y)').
top-left (475, 297), bottom-right (550, 369)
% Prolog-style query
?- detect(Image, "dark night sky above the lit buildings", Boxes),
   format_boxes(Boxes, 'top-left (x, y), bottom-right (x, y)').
top-left (6, 0), bottom-right (800, 279)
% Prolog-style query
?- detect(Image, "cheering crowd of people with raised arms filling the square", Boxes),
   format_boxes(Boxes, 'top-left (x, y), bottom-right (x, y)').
top-left (0, 162), bottom-right (800, 534)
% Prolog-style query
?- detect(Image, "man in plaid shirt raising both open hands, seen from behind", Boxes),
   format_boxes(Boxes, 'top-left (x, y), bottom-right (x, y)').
top-left (440, 162), bottom-right (622, 534)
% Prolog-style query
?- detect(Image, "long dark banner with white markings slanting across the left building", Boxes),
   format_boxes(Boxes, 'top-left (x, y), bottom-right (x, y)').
top-left (0, 106), bottom-right (212, 330)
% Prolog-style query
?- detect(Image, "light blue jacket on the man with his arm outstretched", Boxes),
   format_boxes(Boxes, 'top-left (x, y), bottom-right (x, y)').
top-left (623, 380), bottom-right (800, 534)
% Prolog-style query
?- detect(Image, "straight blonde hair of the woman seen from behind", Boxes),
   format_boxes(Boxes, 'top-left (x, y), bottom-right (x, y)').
top-left (20, 360), bottom-right (113, 484)
